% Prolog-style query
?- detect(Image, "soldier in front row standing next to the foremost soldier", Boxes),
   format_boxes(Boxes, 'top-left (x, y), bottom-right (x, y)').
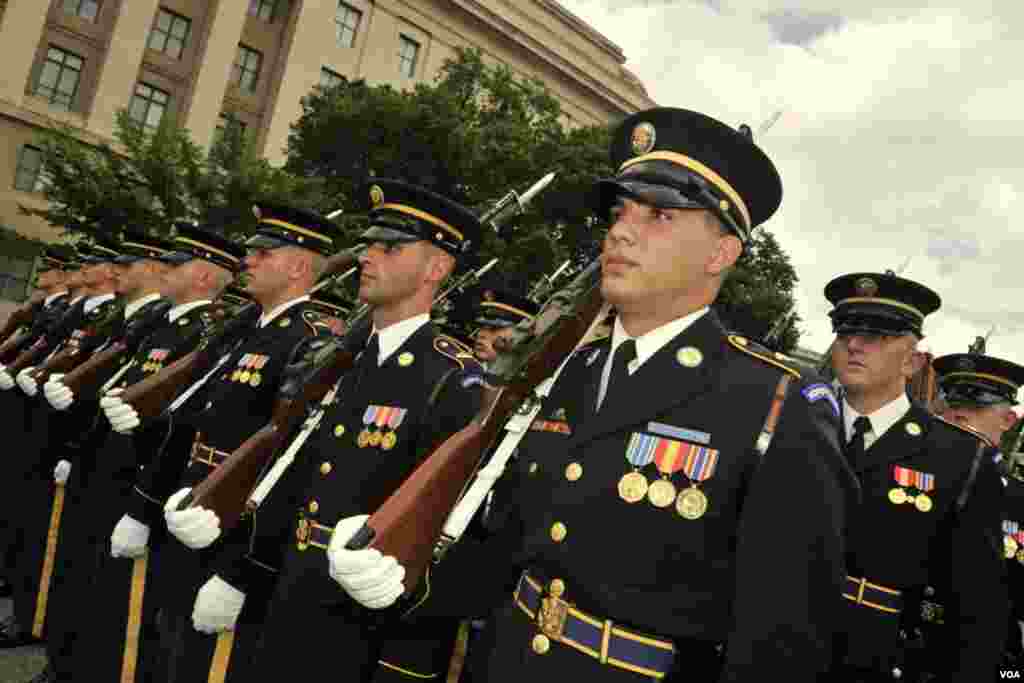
top-left (162, 179), bottom-right (481, 683)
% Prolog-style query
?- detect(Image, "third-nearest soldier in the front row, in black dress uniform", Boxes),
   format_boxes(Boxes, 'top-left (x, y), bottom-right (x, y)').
top-left (97, 203), bottom-right (336, 683)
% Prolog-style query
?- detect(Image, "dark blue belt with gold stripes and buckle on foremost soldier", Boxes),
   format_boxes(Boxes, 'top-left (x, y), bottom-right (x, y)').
top-left (513, 572), bottom-right (676, 679)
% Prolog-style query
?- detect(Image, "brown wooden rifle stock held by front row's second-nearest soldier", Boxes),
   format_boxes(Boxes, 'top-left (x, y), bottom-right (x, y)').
top-left (178, 347), bottom-right (355, 532)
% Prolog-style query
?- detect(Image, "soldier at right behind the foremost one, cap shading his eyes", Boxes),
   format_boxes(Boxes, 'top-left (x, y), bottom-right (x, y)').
top-left (825, 271), bottom-right (1007, 681)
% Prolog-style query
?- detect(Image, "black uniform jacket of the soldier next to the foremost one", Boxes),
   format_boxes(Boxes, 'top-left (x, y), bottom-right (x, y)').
top-left (211, 324), bottom-right (480, 683)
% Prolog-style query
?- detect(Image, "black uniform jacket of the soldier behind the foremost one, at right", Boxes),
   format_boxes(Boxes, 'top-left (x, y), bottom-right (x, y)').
top-left (841, 403), bottom-right (1007, 681)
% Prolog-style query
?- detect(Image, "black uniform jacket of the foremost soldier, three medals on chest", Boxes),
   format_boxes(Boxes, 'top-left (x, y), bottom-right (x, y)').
top-left (412, 313), bottom-right (857, 682)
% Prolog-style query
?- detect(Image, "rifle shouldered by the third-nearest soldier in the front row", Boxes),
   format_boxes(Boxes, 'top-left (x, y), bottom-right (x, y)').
top-left (121, 245), bottom-right (366, 422)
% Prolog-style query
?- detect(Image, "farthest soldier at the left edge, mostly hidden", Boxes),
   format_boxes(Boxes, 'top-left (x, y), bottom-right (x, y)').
top-left (0, 246), bottom-right (80, 649)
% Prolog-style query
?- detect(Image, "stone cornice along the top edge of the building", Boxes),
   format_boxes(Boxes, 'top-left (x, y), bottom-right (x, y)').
top-left (451, 0), bottom-right (654, 116)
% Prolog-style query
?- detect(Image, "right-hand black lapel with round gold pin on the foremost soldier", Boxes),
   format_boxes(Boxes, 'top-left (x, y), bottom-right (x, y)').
top-left (572, 311), bottom-right (726, 446)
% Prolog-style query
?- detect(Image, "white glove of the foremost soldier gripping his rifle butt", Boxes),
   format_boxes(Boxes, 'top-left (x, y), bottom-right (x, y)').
top-left (327, 515), bottom-right (406, 609)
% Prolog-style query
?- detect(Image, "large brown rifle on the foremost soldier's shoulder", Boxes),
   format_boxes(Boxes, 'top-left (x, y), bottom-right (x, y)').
top-left (346, 259), bottom-right (602, 592)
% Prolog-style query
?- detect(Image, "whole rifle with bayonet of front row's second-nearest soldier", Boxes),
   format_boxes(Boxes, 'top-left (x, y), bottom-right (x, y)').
top-left (178, 173), bottom-right (554, 531)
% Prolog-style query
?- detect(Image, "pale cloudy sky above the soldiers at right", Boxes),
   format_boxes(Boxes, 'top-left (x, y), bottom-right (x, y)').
top-left (560, 0), bottom-right (1024, 365)
